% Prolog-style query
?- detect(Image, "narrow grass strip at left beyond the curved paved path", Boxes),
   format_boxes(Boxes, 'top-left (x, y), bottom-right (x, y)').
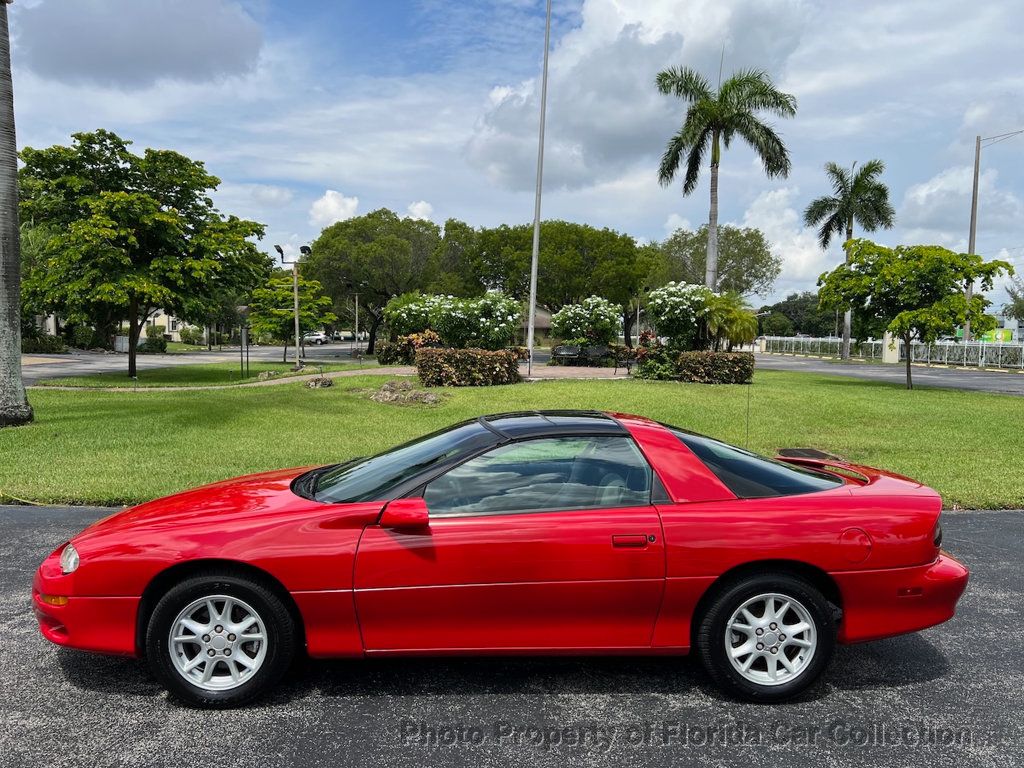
top-left (39, 360), bottom-right (367, 389)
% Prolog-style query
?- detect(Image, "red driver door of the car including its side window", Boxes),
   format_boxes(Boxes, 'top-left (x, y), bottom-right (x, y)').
top-left (354, 435), bottom-right (665, 652)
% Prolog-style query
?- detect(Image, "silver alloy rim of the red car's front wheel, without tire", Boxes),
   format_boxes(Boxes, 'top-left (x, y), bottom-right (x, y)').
top-left (167, 595), bottom-right (267, 691)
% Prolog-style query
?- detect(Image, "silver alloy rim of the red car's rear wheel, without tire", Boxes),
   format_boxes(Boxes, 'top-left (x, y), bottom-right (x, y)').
top-left (725, 592), bottom-right (817, 685)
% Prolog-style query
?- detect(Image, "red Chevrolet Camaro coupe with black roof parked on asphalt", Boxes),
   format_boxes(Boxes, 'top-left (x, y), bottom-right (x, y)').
top-left (33, 411), bottom-right (968, 707)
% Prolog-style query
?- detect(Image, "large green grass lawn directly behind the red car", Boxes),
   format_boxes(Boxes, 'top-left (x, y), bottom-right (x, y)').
top-left (0, 367), bottom-right (1024, 508)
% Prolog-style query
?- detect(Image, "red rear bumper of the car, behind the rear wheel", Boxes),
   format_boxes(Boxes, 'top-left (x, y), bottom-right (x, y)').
top-left (831, 552), bottom-right (970, 643)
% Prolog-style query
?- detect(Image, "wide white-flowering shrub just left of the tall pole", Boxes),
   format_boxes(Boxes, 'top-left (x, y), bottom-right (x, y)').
top-left (384, 293), bottom-right (522, 349)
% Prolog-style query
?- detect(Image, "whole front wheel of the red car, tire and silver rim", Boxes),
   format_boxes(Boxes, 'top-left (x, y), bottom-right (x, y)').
top-left (146, 574), bottom-right (295, 708)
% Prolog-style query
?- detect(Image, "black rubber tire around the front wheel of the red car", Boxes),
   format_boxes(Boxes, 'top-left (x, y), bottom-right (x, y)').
top-left (145, 572), bottom-right (296, 709)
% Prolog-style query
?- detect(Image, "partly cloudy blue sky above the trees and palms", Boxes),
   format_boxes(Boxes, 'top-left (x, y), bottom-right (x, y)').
top-left (10, 0), bottom-right (1024, 304)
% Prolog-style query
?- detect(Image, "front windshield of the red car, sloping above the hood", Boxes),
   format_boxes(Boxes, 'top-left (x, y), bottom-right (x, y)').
top-left (307, 421), bottom-right (497, 504)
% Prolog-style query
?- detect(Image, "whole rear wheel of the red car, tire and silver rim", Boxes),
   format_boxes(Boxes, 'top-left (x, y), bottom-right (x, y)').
top-left (696, 573), bottom-right (837, 702)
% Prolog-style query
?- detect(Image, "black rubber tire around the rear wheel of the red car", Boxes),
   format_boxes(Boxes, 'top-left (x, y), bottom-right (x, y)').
top-left (696, 573), bottom-right (839, 703)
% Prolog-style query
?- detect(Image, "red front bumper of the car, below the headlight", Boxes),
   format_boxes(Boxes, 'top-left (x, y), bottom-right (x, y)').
top-left (32, 572), bottom-right (139, 656)
